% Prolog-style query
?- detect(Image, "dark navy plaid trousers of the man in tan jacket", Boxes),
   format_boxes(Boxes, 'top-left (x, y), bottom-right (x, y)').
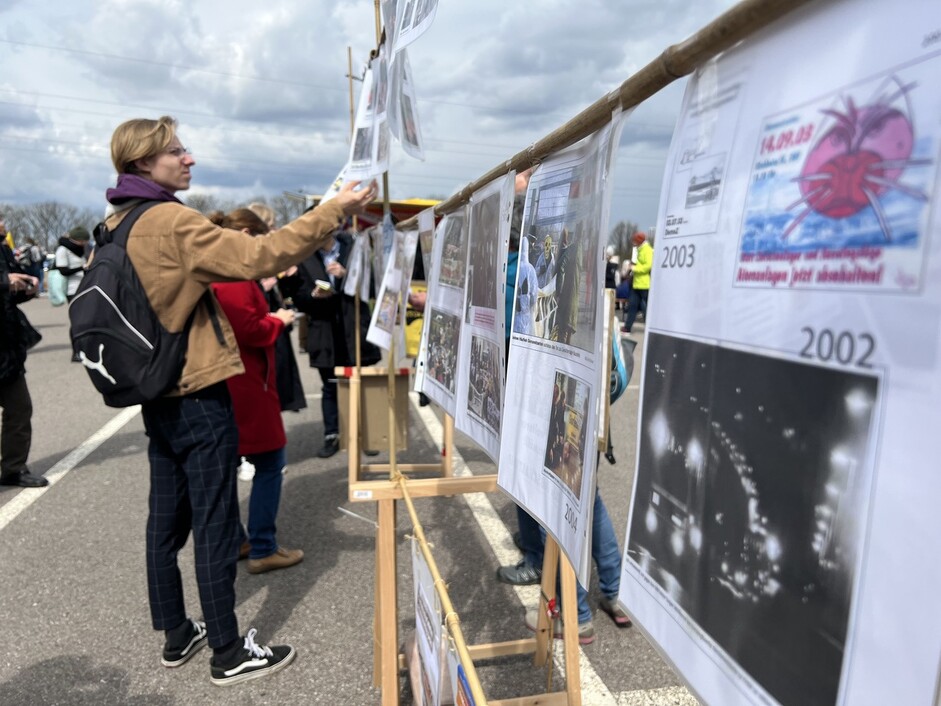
top-left (143, 382), bottom-right (242, 648)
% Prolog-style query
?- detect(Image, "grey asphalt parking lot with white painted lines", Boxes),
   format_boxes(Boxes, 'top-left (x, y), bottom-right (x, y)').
top-left (0, 299), bottom-right (697, 706)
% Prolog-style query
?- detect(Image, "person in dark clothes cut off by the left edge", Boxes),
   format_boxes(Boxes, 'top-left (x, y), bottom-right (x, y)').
top-left (0, 243), bottom-right (49, 488)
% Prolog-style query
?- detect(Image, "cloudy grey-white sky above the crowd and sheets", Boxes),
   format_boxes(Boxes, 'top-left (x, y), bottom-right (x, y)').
top-left (0, 0), bottom-right (734, 227)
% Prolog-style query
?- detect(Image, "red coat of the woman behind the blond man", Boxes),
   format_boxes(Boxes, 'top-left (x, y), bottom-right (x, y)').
top-left (212, 282), bottom-right (287, 455)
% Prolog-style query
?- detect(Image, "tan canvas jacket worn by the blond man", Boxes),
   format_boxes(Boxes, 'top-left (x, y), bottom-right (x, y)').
top-left (106, 201), bottom-right (343, 396)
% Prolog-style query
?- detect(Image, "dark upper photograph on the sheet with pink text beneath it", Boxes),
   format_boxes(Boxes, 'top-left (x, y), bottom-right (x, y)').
top-left (467, 192), bottom-right (500, 322)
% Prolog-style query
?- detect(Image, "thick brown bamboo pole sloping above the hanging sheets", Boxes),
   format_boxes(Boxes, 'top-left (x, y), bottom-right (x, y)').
top-left (400, 0), bottom-right (814, 228)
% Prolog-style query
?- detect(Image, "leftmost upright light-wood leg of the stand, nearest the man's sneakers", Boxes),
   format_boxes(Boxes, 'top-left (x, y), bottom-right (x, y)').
top-left (376, 500), bottom-right (399, 706)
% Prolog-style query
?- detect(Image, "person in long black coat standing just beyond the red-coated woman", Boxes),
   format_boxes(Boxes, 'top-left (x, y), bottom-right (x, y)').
top-left (293, 231), bottom-right (381, 458)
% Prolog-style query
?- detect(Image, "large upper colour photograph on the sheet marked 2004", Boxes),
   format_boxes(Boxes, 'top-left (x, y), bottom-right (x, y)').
top-left (513, 167), bottom-right (601, 351)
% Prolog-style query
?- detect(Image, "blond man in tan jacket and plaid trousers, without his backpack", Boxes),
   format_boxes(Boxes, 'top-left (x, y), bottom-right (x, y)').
top-left (107, 116), bottom-right (376, 686)
